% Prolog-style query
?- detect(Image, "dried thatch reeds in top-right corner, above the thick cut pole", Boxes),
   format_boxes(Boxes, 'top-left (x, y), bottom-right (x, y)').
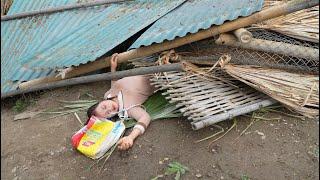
top-left (252, 0), bottom-right (319, 43)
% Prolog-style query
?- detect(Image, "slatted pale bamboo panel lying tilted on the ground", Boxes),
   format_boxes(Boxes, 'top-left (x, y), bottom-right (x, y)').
top-left (151, 65), bottom-right (276, 130)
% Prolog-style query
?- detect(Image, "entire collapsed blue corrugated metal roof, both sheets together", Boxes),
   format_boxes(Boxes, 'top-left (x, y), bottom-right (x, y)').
top-left (1, 0), bottom-right (263, 92)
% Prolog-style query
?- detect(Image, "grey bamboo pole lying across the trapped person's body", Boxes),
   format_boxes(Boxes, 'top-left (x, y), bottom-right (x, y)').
top-left (1, 62), bottom-right (185, 99)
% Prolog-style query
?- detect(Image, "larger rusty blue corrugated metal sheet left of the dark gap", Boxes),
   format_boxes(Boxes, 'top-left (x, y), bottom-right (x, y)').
top-left (1, 0), bottom-right (185, 93)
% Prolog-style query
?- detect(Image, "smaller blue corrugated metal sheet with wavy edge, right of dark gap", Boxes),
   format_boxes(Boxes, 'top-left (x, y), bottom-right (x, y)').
top-left (130, 0), bottom-right (264, 49)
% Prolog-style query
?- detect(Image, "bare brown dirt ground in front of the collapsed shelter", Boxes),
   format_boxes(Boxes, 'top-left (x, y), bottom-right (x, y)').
top-left (1, 83), bottom-right (319, 180)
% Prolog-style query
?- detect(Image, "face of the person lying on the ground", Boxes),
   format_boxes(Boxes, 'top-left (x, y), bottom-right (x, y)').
top-left (94, 100), bottom-right (119, 118)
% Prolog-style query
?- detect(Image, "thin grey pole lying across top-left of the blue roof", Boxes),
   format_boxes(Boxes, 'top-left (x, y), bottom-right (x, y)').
top-left (1, 0), bottom-right (128, 21)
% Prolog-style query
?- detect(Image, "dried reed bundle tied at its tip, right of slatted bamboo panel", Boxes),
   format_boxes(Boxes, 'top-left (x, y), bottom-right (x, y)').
top-left (220, 55), bottom-right (319, 118)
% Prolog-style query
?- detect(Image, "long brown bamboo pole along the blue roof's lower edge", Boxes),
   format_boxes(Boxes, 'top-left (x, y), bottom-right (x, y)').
top-left (19, 0), bottom-right (319, 89)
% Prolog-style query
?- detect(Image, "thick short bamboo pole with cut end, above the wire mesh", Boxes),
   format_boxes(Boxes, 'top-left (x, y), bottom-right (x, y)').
top-left (215, 34), bottom-right (319, 61)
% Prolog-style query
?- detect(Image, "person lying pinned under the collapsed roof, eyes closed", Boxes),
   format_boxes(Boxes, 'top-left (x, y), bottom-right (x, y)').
top-left (87, 54), bottom-right (155, 150)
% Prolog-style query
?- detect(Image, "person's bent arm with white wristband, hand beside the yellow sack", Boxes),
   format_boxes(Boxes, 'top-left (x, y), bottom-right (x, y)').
top-left (118, 107), bottom-right (151, 150)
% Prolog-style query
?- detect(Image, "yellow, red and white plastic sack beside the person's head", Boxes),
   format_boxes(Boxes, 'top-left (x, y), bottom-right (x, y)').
top-left (71, 116), bottom-right (125, 159)
